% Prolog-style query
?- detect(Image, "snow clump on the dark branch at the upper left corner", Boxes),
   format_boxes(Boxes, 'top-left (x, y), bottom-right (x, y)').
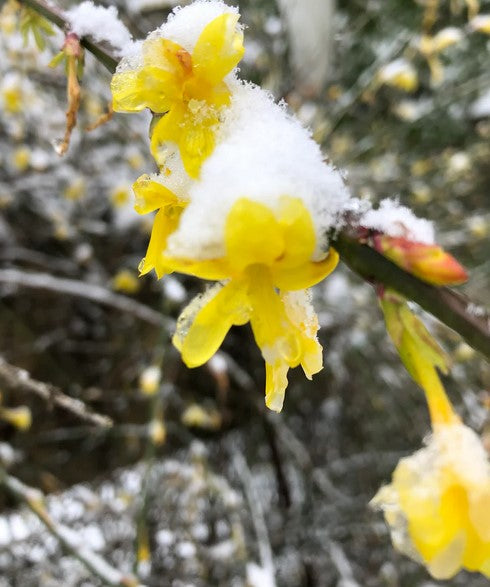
top-left (65, 0), bottom-right (133, 57)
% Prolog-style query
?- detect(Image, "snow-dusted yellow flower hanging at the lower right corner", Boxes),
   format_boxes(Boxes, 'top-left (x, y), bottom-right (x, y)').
top-left (372, 386), bottom-right (490, 579)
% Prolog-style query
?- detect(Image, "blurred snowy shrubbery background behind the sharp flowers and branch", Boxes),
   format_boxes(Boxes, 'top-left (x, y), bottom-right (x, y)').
top-left (0, 0), bottom-right (490, 587)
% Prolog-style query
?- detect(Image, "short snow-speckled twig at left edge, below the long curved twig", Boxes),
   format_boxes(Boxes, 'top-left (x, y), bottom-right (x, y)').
top-left (0, 357), bottom-right (113, 428)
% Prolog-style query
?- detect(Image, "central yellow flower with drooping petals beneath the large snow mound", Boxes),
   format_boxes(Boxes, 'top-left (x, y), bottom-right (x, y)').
top-left (164, 196), bottom-right (338, 411)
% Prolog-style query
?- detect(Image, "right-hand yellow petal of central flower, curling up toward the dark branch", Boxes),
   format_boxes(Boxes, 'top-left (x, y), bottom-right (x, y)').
top-left (272, 248), bottom-right (339, 291)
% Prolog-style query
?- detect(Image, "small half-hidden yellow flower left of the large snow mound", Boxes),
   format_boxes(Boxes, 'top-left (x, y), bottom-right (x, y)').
top-left (133, 175), bottom-right (187, 278)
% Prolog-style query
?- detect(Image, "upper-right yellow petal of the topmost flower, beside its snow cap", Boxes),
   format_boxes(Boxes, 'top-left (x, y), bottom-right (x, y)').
top-left (192, 13), bottom-right (245, 85)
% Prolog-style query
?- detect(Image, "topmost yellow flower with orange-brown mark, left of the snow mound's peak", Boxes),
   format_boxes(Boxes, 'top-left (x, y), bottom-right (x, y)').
top-left (111, 13), bottom-right (244, 178)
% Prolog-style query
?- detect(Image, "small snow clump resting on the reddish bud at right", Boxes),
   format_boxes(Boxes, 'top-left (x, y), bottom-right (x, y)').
top-left (359, 198), bottom-right (434, 244)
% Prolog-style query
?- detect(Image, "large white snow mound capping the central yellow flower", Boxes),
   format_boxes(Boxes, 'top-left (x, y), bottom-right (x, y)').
top-left (167, 82), bottom-right (350, 259)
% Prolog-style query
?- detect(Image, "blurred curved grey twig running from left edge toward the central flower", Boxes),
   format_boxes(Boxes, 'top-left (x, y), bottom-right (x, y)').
top-left (0, 269), bottom-right (174, 330)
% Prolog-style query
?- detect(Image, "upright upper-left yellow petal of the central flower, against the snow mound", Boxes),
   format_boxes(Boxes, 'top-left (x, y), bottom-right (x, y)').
top-left (225, 199), bottom-right (284, 272)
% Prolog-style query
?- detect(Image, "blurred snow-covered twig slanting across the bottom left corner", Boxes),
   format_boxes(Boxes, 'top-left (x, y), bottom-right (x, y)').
top-left (0, 467), bottom-right (143, 587)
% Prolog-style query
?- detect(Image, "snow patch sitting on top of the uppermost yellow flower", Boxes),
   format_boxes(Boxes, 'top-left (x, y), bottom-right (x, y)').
top-left (154, 0), bottom-right (238, 52)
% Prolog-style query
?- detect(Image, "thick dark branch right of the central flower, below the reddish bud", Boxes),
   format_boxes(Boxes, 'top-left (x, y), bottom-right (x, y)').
top-left (332, 232), bottom-right (490, 358)
